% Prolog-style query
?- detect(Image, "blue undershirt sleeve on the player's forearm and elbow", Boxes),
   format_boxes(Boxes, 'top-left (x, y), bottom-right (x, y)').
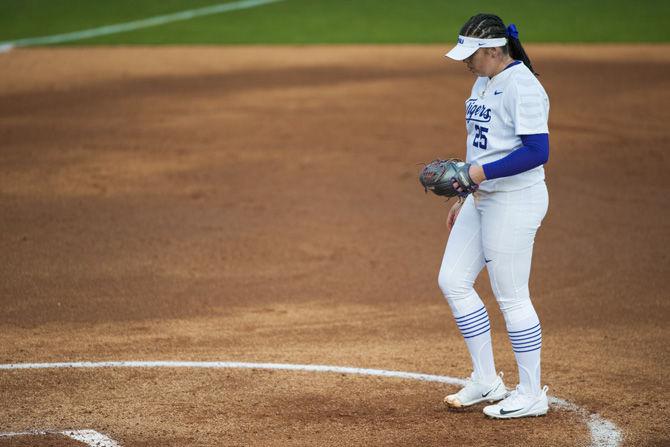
top-left (482, 133), bottom-right (549, 180)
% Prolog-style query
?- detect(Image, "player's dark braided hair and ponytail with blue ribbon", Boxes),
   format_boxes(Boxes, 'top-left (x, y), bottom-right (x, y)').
top-left (460, 14), bottom-right (537, 76)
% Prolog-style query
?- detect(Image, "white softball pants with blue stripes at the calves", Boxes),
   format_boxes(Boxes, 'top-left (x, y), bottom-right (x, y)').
top-left (438, 182), bottom-right (548, 393)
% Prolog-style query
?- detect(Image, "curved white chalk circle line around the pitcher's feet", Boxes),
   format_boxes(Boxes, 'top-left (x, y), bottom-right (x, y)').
top-left (0, 361), bottom-right (622, 447)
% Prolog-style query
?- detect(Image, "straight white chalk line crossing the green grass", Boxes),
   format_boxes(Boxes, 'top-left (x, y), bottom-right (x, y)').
top-left (0, 0), bottom-right (283, 52)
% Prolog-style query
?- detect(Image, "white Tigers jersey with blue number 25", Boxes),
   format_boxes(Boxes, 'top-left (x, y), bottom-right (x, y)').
top-left (465, 62), bottom-right (549, 192)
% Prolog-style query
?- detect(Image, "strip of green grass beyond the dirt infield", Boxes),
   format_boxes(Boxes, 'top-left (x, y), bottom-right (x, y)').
top-left (0, 0), bottom-right (670, 45)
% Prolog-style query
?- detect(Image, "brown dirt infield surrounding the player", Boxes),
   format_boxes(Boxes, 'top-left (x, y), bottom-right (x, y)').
top-left (0, 45), bottom-right (670, 446)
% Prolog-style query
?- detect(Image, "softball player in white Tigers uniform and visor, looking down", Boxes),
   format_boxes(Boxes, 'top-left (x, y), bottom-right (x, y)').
top-left (438, 14), bottom-right (549, 418)
